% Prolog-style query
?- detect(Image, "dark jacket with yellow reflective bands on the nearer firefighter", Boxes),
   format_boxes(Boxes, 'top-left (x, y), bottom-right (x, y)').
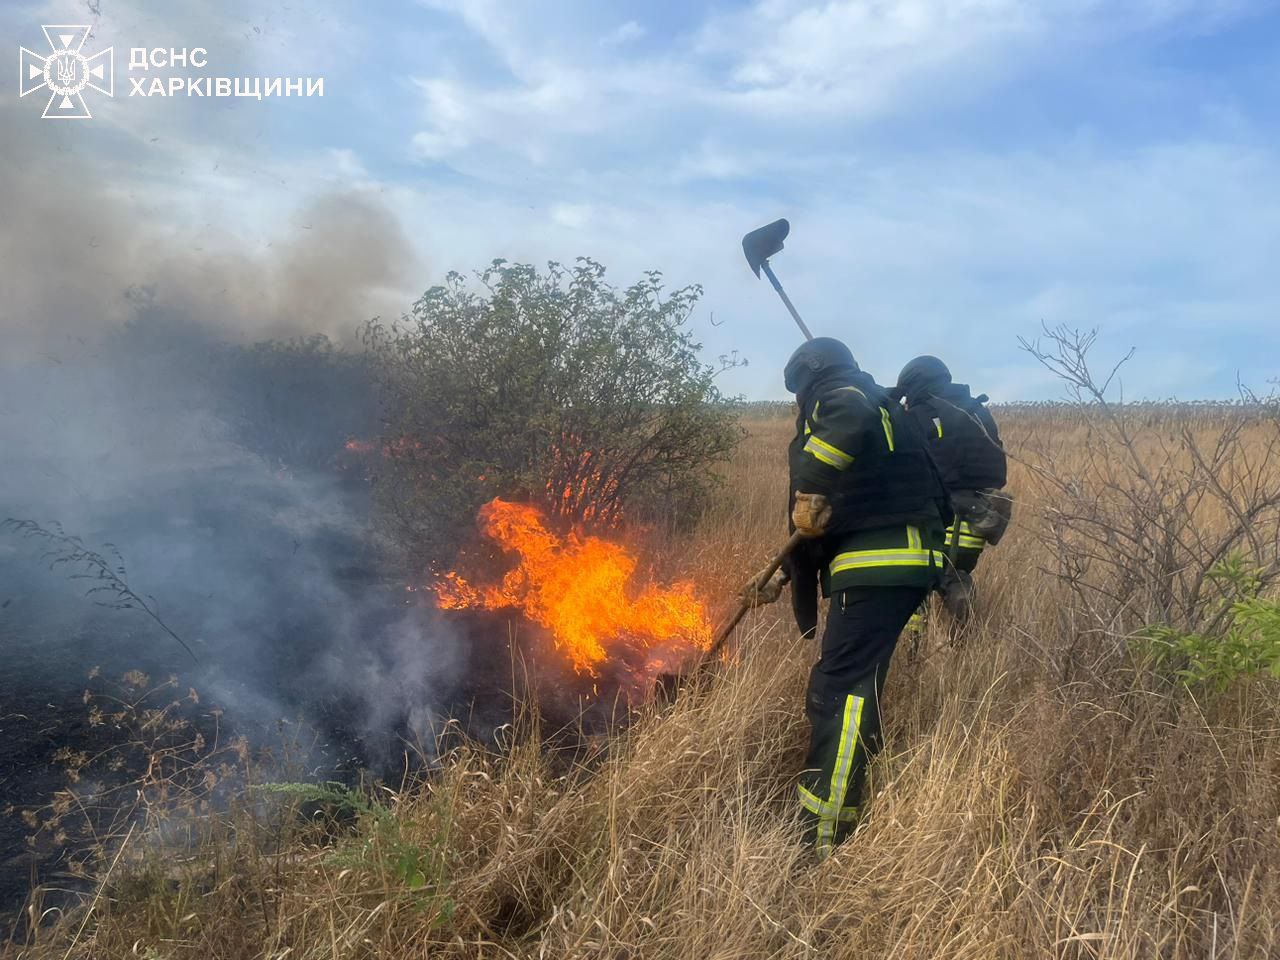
top-left (790, 369), bottom-right (950, 594)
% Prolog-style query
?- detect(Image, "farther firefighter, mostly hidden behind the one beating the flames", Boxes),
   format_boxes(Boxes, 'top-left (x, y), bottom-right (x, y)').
top-left (890, 356), bottom-right (1011, 626)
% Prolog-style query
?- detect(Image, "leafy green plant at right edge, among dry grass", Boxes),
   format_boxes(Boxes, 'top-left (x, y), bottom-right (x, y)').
top-left (1139, 554), bottom-right (1280, 692)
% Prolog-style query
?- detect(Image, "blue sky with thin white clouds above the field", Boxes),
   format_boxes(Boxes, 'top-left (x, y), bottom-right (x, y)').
top-left (0, 0), bottom-right (1280, 399)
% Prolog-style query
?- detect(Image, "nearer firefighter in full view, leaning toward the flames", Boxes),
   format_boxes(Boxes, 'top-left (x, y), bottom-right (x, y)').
top-left (762, 337), bottom-right (946, 858)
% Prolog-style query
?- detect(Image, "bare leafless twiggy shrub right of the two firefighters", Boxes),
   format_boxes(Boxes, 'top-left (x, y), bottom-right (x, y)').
top-left (1023, 326), bottom-right (1280, 640)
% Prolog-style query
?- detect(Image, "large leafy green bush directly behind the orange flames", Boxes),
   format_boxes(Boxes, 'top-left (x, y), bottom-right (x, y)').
top-left (366, 259), bottom-right (740, 568)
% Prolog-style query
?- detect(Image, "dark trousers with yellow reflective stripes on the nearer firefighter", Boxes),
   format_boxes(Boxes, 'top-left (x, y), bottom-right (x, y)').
top-left (799, 586), bottom-right (928, 856)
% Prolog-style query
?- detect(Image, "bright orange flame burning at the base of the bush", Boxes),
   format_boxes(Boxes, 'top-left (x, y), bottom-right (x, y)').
top-left (435, 499), bottom-right (712, 675)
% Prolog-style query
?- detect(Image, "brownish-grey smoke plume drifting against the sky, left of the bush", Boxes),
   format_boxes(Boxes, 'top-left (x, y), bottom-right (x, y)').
top-left (0, 94), bottom-right (416, 358)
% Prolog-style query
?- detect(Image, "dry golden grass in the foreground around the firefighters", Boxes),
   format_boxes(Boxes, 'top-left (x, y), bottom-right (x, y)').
top-left (10, 413), bottom-right (1280, 960)
